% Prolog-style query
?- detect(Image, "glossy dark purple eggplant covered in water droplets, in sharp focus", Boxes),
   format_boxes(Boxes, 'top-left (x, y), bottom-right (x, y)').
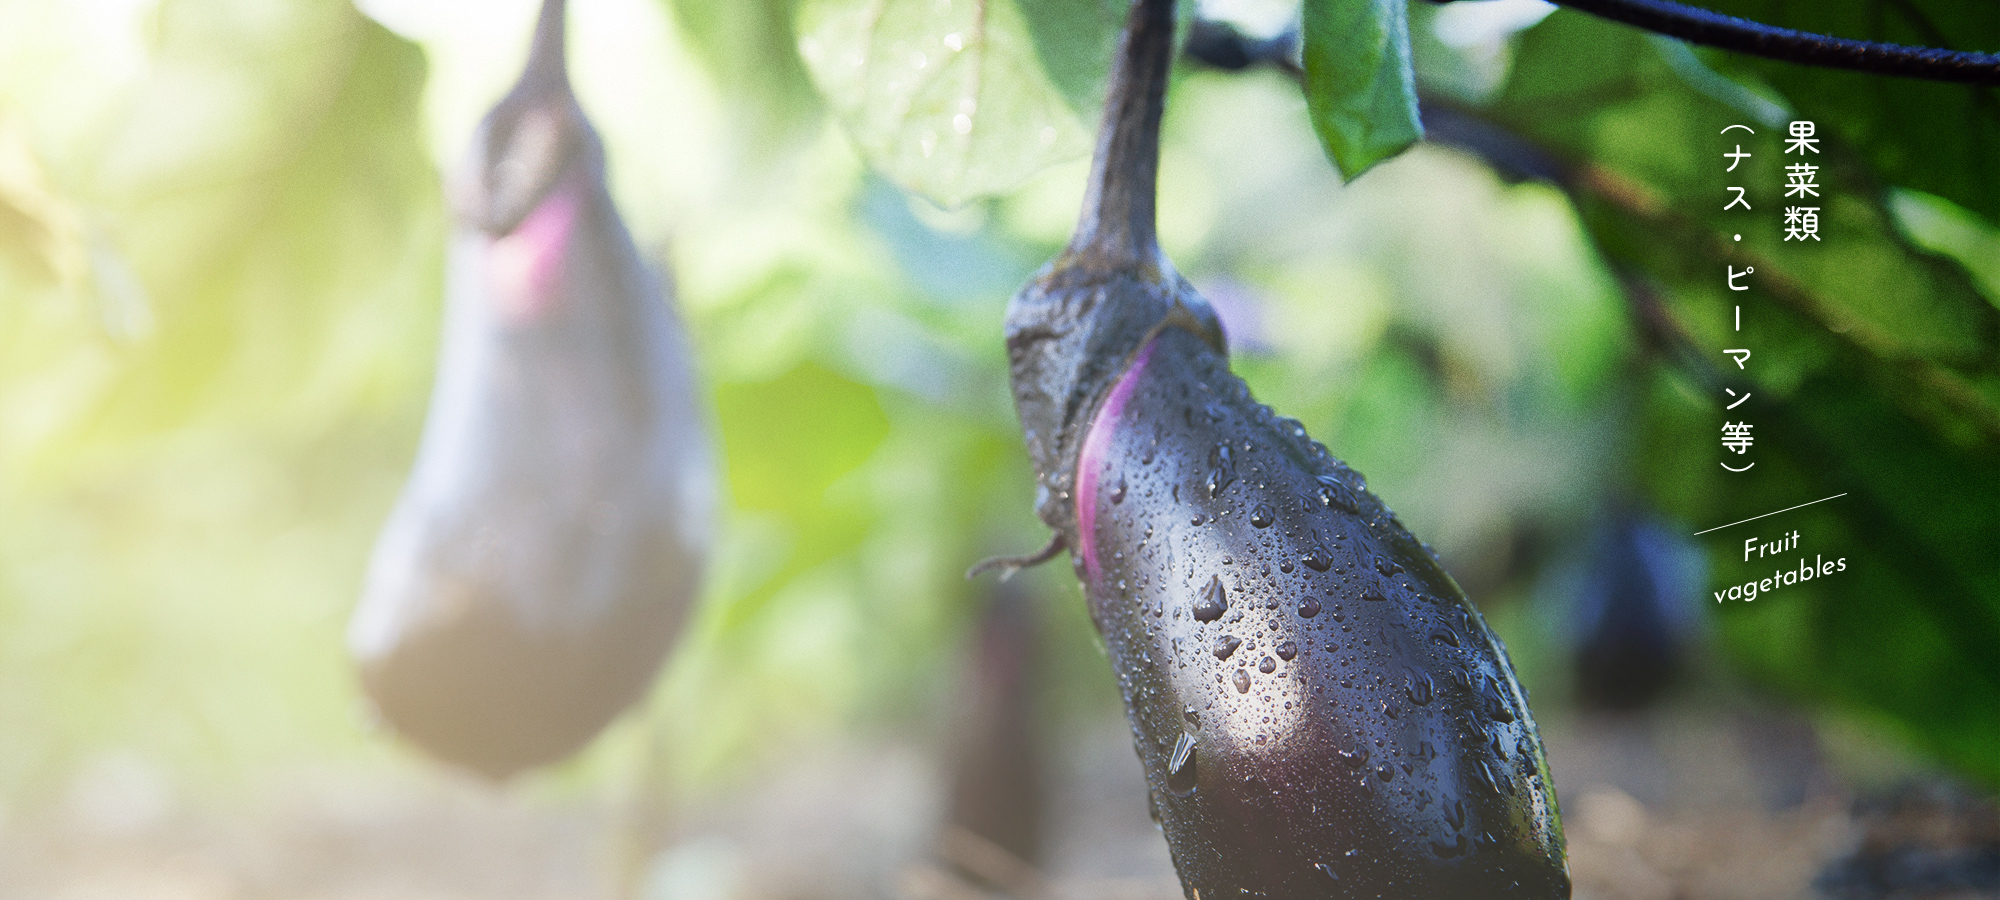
top-left (1006, 0), bottom-right (1570, 900)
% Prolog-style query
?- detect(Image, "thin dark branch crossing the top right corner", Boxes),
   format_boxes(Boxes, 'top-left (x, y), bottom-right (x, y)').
top-left (1554, 0), bottom-right (2000, 86)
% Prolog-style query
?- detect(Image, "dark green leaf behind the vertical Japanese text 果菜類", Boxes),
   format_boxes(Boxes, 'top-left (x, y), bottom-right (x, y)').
top-left (1490, 10), bottom-right (2000, 400)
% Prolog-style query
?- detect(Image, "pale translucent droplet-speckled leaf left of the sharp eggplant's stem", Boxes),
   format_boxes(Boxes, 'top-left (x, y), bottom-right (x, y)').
top-left (798, 0), bottom-right (1112, 206)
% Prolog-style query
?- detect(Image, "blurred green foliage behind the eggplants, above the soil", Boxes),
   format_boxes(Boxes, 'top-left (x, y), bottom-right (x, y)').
top-left (0, 0), bottom-right (2000, 872)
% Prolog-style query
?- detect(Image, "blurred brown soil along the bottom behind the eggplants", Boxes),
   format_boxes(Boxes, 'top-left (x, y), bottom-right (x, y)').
top-left (0, 712), bottom-right (1982, 900)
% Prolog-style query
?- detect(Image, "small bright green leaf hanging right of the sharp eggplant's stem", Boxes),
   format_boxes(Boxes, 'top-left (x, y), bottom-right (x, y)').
top-left (1304, 0), bottom-right (1424, 178)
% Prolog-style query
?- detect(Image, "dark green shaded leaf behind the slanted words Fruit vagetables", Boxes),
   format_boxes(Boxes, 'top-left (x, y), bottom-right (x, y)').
top-left (1700, 356), bottom-right (2000, 784)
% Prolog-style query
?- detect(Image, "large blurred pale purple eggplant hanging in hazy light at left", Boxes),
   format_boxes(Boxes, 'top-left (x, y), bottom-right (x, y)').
top-left (348, 0), bottom-right (714, 778)
